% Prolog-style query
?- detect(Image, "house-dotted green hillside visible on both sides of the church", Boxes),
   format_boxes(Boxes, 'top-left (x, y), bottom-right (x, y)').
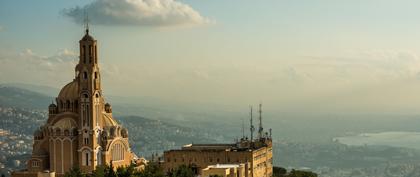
top-left (0, 86), bottom-right (228, 172)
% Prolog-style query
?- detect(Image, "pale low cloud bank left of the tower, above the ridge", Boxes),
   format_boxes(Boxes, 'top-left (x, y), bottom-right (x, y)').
top-left (0, 49), bottom-right (78, 85)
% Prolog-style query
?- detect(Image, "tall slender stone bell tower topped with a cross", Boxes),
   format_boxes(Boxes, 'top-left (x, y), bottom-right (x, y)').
top-left (75, 25), bottom-right (105, 171)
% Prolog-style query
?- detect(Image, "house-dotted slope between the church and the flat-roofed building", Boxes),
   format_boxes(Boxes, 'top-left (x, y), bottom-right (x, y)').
top-left (116, 116), bottom-right (226, 156)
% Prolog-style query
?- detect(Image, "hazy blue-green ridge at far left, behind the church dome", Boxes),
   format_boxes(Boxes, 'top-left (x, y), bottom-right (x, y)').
top-left (0, 85), bottom-right (53, 109)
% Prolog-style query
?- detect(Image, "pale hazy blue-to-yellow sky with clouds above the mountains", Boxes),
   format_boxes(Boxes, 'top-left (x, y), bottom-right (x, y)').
top-left (0, 0), bottom-right (420, 114)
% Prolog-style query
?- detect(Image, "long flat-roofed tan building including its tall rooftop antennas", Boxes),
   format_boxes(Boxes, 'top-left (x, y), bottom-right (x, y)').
top-left (163, 104), bottom-right (273, 177)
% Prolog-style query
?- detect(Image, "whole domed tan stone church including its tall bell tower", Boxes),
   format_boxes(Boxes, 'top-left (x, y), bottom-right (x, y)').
top-left (12, 28), bottom-right (135, 177)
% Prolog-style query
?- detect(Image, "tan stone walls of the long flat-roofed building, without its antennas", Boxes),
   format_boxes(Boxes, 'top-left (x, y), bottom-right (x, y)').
top-left (163, 137), bottom-right (273, 177)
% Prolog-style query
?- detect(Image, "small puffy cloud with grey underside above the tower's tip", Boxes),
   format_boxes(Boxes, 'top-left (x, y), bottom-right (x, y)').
top-left (63, 0), bottom-right (212, 27)
